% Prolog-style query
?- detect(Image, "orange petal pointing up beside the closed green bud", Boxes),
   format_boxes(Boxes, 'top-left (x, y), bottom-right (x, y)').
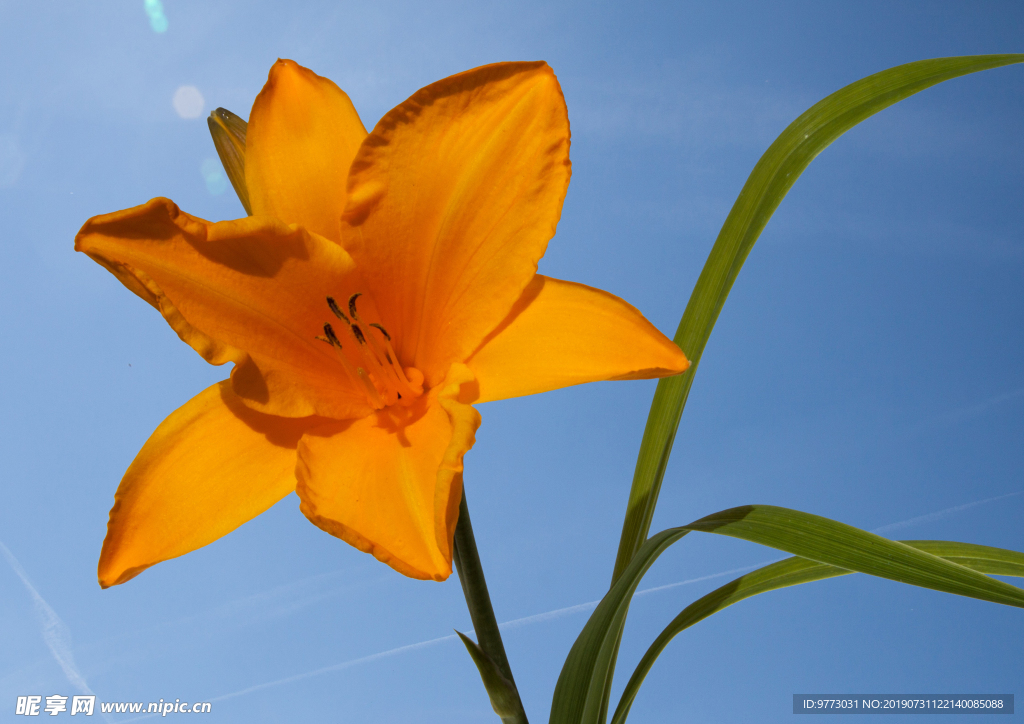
top-left (246, 59), bottom-right (367, 242)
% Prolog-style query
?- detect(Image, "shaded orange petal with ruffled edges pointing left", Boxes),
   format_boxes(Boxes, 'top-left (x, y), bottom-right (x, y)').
top-left (75, 199), bottom-right (373, 419)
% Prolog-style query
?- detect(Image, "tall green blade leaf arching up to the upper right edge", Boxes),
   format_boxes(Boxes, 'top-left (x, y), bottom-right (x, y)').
top-left (612, 54), bottom-right (1024, 580)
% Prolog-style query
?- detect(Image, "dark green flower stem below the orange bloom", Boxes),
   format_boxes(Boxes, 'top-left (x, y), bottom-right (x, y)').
top-left (453, 487), bottom-right (527, 724)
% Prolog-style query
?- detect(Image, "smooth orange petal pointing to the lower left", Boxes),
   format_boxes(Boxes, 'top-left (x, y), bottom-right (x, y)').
top-left (98, 380), bottom-right (323, 588)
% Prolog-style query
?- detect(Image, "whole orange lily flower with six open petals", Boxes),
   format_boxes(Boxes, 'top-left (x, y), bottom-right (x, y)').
top-left (75, 60), bottom-right (689, 588)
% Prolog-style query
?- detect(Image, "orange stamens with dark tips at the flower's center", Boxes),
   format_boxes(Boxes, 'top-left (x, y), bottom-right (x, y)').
top-left (316, 292), bottom-right (423, 410)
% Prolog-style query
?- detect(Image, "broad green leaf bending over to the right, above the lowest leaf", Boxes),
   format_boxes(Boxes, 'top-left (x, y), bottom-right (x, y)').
top-left (550, 506), bottom-right (1024, 724)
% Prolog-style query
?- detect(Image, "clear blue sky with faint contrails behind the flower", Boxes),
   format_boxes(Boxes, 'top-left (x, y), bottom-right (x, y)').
top-left (0, 0), bottom-right (1024, 723)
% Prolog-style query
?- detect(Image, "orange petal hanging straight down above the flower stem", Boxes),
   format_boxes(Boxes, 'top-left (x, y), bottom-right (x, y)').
top-left (296, 365), bottom-right (480, 581)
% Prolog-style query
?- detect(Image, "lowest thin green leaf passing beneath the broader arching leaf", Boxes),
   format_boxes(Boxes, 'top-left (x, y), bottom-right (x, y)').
top-left (611, 541), bottom-right (1024, 724)
